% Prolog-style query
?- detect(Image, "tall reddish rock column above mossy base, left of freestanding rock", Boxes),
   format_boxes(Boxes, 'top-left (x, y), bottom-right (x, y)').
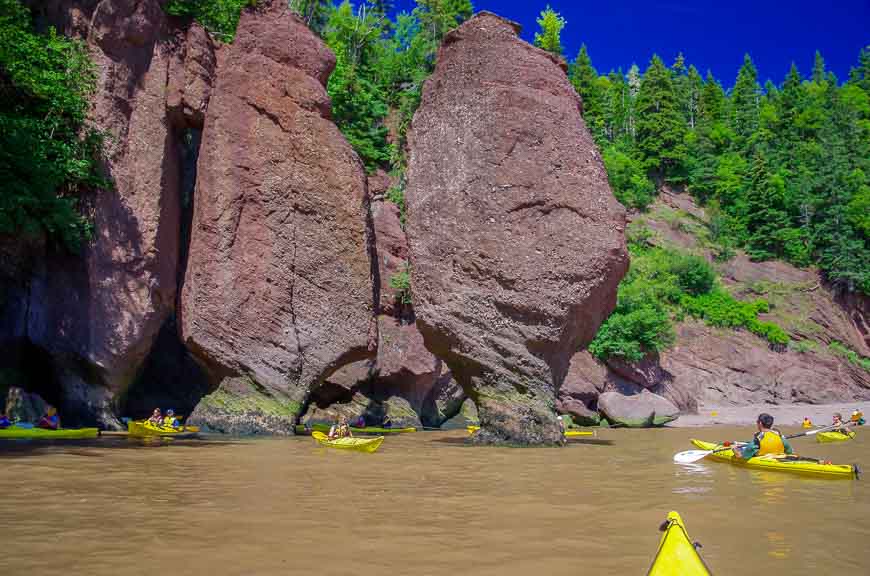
top-left (180, 0), bottom-right (374, 433)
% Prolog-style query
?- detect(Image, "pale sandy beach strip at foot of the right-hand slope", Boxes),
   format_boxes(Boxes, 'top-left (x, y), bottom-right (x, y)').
top-left (668, 402), bottom-right (870, 428)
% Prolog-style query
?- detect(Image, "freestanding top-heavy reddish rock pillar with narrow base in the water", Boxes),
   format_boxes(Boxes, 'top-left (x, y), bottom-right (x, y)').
top-left (406, 13), bottom-right (628, 444)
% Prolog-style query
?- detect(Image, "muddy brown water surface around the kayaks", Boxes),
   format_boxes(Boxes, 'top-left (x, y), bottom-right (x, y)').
top-left (0, 428), bottom-right (870, 576)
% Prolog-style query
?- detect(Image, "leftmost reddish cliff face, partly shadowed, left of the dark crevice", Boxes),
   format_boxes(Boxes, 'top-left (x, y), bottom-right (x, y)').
top-left (11, 0), bottom-right (214, 426)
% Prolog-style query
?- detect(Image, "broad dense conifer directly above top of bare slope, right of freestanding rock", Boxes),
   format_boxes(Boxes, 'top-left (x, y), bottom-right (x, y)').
top-left (636, 56), bottom-right (686, 176)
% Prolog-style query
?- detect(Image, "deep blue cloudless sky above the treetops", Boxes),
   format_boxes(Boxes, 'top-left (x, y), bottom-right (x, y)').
top-left (397, 0), bottom-right (870, 87)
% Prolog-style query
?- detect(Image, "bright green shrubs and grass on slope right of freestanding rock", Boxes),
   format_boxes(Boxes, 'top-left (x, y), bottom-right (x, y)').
top-left (589, 224), bottom-right (789, 362)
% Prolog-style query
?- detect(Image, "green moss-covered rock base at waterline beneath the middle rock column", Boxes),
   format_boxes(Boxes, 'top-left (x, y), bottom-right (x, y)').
top-left (187, 376), bottom-right (300, 436)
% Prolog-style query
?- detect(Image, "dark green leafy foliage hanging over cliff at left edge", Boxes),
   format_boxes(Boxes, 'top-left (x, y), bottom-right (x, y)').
top-left (0, 0), bottom-right (108, 251)
